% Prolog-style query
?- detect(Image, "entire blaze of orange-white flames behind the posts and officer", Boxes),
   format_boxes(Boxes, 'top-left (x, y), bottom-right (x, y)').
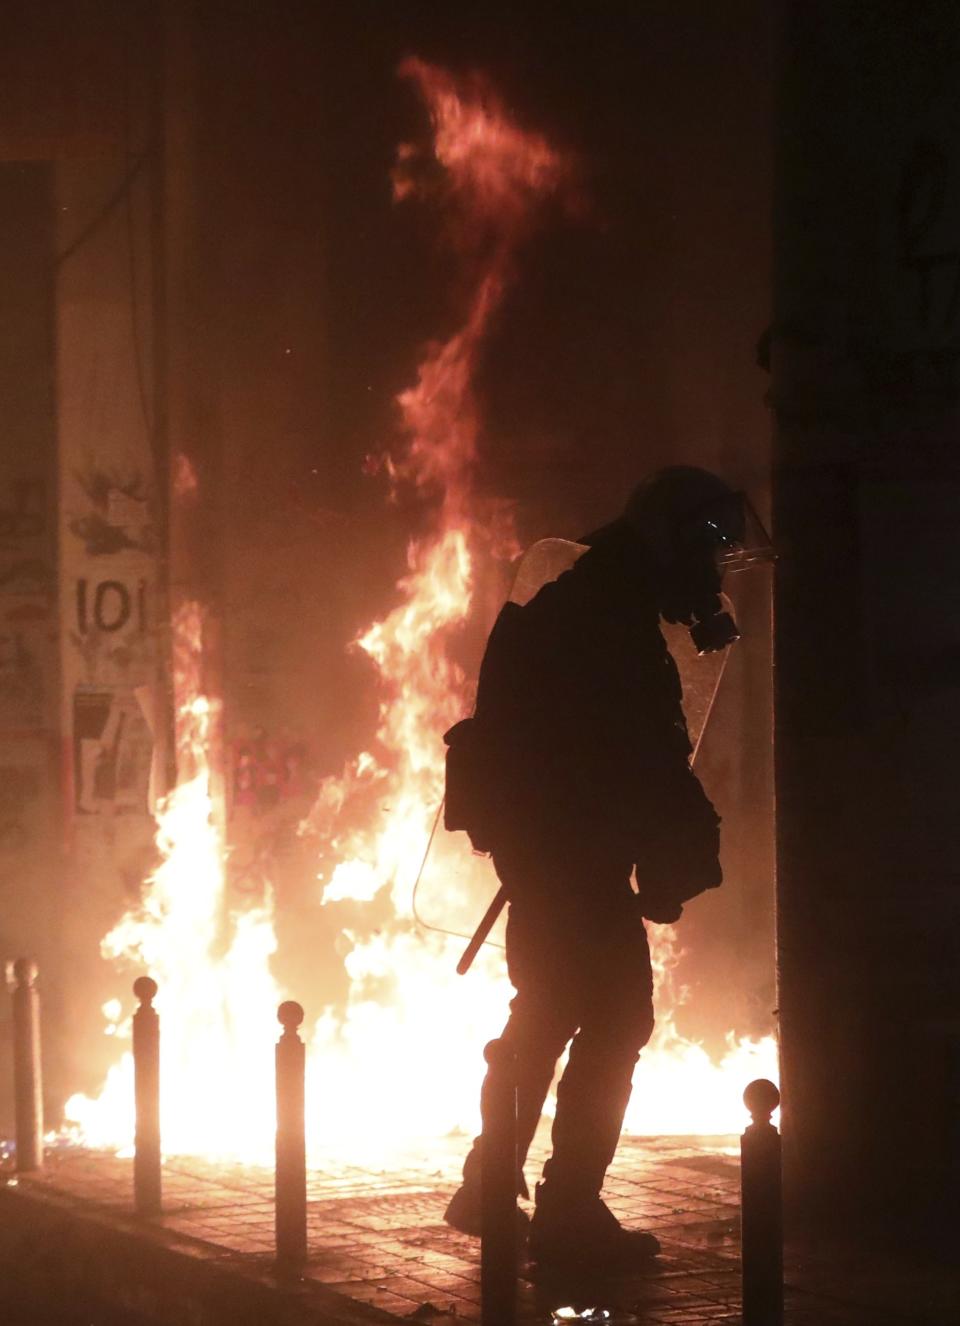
top-left (68, 60), bottom-right (776, 1163)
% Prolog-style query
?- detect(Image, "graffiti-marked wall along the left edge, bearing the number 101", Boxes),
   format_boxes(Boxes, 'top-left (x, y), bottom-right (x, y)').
top-left (0, 0), bottom-right (159, 1123)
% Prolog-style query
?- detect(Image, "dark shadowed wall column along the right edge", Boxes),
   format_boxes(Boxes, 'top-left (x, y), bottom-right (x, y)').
top-left (773, 0), bottom-right (960, 1229)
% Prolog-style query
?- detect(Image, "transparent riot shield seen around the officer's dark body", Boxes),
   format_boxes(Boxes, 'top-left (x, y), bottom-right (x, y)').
top-left (414, 538), bottom-right (729, 947)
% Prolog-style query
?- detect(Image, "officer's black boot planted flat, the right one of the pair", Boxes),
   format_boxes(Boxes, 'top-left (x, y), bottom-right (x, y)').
top-left (530, 1183), bottom-right (660, 1272)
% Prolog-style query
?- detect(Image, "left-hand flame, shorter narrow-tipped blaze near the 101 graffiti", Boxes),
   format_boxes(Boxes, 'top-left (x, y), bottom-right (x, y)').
top-left (66, 602), bottom-right (280, 1160)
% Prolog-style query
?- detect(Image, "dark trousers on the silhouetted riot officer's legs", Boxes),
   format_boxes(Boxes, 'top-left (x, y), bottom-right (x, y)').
top-left (464, 853), bottom-right (654, 1201)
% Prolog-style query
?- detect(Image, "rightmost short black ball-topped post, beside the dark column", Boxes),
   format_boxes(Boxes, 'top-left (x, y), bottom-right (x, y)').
top-left (740, 1078), bottom-right (784, 1326)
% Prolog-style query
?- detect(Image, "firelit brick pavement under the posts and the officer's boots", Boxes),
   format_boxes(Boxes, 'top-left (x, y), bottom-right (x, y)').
top-left (3, 1138), bottom-right (960, 1326)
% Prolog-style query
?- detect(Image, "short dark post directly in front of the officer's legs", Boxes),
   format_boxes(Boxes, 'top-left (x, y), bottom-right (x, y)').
top-left (480, 1041), bottom-right (517, 1326)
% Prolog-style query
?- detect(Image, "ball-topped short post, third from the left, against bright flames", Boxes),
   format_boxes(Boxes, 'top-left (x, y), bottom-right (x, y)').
top-left (274, 1000), bottom-right (306, 1280)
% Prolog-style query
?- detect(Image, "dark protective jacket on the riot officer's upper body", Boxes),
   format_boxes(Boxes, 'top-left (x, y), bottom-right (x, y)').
top-left (447, 529), bottom-right (721, 917)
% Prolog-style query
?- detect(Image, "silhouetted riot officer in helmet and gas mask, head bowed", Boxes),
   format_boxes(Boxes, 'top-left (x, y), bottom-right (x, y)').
top-left (446, 467), bottom-right (753, 1266)
